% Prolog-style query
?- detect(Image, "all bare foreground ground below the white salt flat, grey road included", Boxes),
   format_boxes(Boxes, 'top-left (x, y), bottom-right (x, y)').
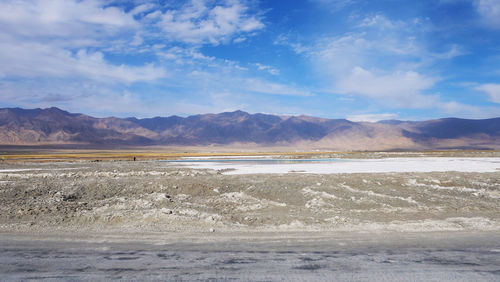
top-left (0, 155), bottom-right (500, 281)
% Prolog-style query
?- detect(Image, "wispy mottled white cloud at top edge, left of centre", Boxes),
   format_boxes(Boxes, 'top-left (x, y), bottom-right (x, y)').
top-left (156, 0), bottom-right (264, 45)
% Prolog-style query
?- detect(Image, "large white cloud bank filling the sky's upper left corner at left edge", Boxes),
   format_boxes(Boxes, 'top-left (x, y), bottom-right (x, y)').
top-left (0, 0), bottom-right (165, 84)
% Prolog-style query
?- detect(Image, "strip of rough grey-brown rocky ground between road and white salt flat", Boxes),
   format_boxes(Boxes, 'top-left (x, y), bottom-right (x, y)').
top-left (0, 154), bottom-right (500, 233)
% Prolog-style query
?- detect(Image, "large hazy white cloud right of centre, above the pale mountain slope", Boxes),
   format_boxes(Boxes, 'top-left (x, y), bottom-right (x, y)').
top-left (308, 15), bottom-right (442, 108)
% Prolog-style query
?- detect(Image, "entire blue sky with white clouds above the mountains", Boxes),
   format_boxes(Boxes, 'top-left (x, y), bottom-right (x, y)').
top-left (0, 0), bottom-right (500, 121)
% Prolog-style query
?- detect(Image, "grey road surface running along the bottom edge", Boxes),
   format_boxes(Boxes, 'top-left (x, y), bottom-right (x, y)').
top-left (0, 232), bottom-right (500, 281)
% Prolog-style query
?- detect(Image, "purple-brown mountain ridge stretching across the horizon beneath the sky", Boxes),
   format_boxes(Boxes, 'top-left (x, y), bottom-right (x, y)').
top-left (0, 107), bottom-right (500, 150)
